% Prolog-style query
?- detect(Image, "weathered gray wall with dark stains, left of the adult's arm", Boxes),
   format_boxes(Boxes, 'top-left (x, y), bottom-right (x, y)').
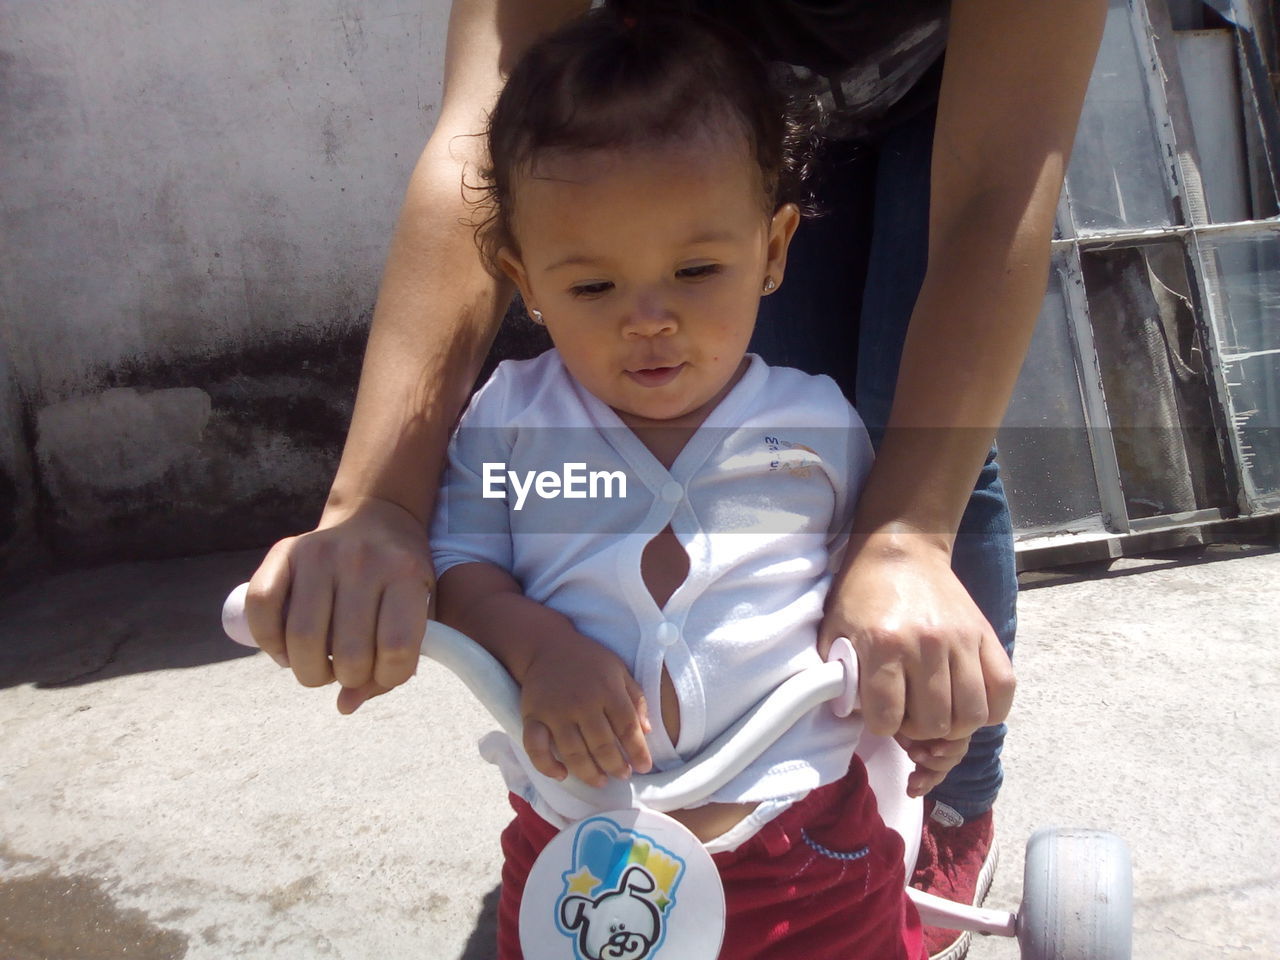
top-left (0, 0), bottom-right (448, 572)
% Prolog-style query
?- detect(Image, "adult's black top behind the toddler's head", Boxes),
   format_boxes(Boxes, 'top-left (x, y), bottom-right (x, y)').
top-left (611, 0), bottom-right (951, 140)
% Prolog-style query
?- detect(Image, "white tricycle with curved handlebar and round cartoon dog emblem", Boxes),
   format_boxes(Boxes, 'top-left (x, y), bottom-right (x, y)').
top-left (223, 585), bottom-right (1133, 960)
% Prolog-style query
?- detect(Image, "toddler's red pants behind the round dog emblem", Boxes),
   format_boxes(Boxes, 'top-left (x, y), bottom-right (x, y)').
top-left (498, 758), bottom-right (928, 960)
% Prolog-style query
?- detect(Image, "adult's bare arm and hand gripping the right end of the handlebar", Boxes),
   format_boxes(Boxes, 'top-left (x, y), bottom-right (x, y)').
top-left (823, 0), bottom-right (1107, 740)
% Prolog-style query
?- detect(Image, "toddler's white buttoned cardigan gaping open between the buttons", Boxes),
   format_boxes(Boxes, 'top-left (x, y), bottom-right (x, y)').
top-left (431, 349), bottom-right (873, 834)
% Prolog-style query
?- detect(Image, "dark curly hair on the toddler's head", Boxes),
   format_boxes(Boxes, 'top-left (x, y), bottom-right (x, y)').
top-left (474, 5), bottom-right (818, 271)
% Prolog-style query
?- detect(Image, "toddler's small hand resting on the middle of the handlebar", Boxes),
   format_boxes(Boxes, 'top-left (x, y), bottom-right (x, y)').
top-left (521, 636), bottom-right (653, 787)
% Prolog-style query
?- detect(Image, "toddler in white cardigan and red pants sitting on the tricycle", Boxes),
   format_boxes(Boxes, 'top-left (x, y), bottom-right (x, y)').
top-left (430, 10), bottom-right (923, 960)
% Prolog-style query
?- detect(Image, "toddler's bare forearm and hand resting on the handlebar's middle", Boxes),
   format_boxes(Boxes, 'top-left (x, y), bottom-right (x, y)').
top-left (436, 563), bottom-right (653, 787)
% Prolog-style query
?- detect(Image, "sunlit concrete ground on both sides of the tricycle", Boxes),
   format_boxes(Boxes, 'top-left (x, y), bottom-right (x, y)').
top-left (0, 547), bottom-right (1280, 960)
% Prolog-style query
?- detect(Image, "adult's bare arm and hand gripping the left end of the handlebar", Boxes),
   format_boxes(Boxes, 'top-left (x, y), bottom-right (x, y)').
top-left (246, 0), bottom-right (590, 713)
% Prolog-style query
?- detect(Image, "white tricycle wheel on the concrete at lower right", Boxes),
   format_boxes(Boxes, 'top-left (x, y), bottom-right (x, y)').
top-left (1018, 829), bottom-right (1133, 960)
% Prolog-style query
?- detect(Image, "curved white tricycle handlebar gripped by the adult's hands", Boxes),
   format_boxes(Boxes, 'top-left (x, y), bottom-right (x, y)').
top-left (223, 584), bottom-right (858, 810)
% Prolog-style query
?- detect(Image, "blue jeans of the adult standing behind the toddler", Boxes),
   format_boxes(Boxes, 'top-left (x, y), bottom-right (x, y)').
top-left (751, 103), bottom-right (1018, 817)
